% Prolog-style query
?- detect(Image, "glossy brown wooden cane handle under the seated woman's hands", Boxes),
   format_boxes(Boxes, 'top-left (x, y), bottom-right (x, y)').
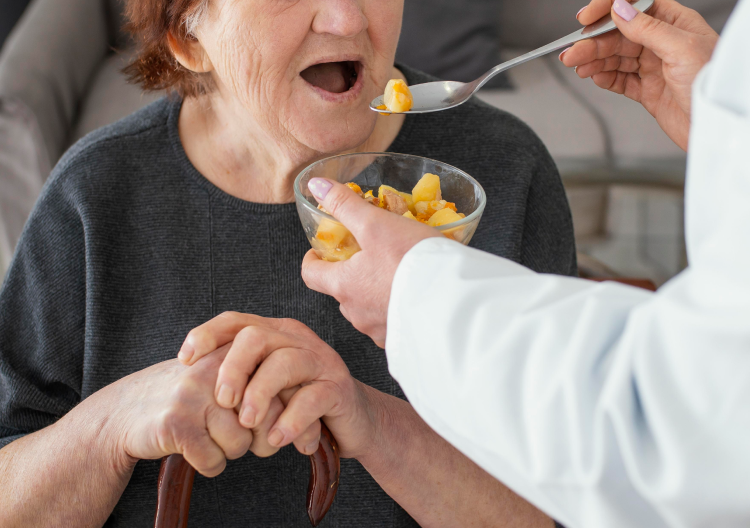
top-left (154, 423), bottom-right (341, 528)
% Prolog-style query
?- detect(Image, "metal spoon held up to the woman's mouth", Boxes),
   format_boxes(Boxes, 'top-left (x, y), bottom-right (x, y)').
top-left (370, 0), bottom-right (654, 114)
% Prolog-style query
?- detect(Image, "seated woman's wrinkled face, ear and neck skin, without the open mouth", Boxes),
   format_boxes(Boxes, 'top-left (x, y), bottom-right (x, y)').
top-left (176, 0), bottom-right (403, 202)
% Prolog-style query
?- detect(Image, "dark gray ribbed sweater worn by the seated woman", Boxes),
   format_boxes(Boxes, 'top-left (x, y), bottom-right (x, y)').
top-left (0, 68), bottom-right (576, 528)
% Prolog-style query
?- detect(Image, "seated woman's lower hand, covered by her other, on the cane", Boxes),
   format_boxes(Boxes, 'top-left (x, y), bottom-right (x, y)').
top-left (106, 347), bottom-right (252, 477)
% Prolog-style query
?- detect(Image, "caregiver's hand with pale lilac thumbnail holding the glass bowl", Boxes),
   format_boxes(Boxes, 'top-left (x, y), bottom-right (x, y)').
top-left (302, 178), bottom-right (442, 348)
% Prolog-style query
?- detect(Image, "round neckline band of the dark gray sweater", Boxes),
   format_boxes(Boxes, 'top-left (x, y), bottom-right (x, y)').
top-left (167, 65), bottom-right (414, 214)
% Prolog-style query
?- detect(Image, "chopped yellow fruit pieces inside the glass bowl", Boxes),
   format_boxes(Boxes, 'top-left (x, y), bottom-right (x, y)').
top-left (311, 173), bottom-right (466, 262)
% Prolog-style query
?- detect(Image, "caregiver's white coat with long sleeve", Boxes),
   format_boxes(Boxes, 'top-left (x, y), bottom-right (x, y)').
top-left (386, 0), bottom-right (750, 528)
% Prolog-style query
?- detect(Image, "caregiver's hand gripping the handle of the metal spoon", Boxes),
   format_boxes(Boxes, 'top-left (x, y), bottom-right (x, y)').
top-left (560, 0), bottom-right (719, 150)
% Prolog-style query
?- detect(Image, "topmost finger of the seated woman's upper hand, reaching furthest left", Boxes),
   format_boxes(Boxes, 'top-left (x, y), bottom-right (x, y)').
top-left (177, 312), bottom-right (279, 365)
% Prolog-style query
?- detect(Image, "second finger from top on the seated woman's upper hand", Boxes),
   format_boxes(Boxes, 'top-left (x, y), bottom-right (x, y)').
top-left (215, 326), bottom-right (306, 410)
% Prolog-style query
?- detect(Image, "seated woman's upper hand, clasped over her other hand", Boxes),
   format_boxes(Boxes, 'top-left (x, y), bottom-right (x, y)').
top-left (179, 312), bottom-right (378, 458)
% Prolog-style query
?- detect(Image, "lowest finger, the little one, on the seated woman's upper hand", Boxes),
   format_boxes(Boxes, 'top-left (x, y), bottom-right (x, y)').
top-left (268, 382), bottom-right (339, 455)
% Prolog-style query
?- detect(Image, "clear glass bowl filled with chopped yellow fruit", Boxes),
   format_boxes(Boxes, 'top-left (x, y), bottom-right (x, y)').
top-left (294, 153), bottom-right (486, 261)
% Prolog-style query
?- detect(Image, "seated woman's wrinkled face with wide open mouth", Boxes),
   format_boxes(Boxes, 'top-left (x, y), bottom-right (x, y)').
top-left (197, 0), bottom-right (403, 153)
